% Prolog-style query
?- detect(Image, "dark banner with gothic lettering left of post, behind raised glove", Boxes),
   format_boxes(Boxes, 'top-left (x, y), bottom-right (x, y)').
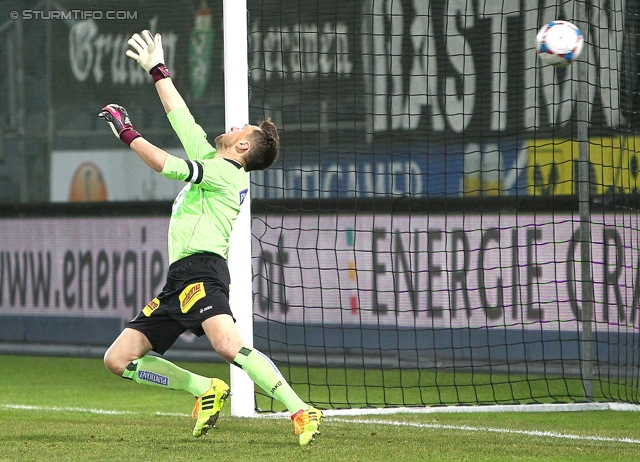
top-left (51, 1), bottom-right (223, 105)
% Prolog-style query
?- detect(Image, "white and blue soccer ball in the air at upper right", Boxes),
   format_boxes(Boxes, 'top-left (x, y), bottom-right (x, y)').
top-left (536, 21), bottom-right (584, 67)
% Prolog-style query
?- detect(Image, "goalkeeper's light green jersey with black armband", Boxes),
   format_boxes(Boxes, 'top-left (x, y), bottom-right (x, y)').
top-left (161, 107), bottom-right (249, 263)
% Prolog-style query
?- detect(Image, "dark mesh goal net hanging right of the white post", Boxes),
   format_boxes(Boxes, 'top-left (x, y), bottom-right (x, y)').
top-left (248, 0), bottom-right (640, 411)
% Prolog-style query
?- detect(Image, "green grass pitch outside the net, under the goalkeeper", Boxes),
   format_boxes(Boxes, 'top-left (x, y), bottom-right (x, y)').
top-left (0, 356), bottom-right (640, 462)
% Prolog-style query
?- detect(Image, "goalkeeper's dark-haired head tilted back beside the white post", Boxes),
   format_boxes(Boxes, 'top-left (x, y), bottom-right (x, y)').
top-left (215, 119), bottom-right (280, 172)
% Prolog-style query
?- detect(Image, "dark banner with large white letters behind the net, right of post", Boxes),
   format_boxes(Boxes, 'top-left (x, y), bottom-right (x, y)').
top-left (249, 0), bottom-right (637, 141)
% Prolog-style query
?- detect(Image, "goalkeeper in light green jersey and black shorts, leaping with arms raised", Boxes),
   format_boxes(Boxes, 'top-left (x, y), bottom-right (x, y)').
top-left (100, 30), bottom-right (323, 446)
